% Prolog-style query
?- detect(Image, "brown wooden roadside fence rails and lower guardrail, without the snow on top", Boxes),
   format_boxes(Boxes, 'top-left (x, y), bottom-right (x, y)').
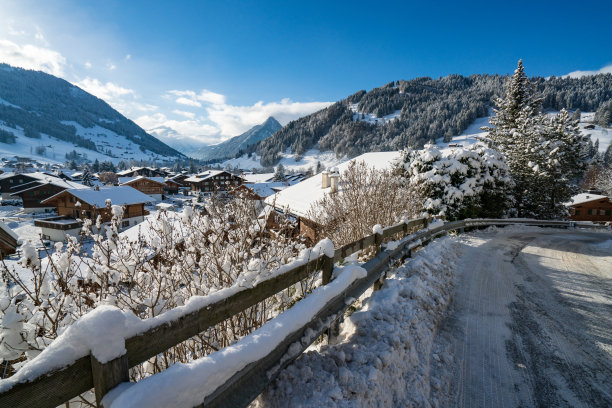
top-left (0, 218), bottom-right (607, 408)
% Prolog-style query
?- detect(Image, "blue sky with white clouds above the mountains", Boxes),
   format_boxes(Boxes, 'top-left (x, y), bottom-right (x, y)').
top-left (0, 0), bottom-right (612, 143)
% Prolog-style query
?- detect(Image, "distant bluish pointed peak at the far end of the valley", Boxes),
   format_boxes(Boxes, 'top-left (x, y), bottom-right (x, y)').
top-left (189, 117), bottom-right (282, 161)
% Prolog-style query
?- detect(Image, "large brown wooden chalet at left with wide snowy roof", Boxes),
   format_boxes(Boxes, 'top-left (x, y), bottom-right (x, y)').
top-left (34, 186), bottom-right (153, 241)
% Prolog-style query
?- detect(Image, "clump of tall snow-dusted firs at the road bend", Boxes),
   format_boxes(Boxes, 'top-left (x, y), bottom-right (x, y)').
top-left (483, 60), bottom-right (589, 218)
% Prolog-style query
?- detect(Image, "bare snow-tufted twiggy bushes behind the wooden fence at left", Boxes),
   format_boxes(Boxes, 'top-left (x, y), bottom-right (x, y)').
top-left (0, 196), bottom-right (308, 394)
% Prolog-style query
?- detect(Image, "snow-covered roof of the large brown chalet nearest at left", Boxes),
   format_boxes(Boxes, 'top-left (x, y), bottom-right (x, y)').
top-left (43, 186), bottom-right (155, 208)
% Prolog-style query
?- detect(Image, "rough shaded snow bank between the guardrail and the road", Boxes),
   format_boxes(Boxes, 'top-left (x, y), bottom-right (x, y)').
top-left (254, 237), bottom-right (461, 407)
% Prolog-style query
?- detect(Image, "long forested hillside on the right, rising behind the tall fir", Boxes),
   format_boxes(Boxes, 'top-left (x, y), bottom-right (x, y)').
top-left (253, 74), bottom-right (612, 166)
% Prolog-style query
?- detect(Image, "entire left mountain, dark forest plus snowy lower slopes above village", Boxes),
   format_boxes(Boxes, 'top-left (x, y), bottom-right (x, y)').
top-left (0, 64), bottom-right (184, 163)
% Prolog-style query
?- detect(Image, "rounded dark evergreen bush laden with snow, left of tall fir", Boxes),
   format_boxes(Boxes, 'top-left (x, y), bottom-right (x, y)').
top-left (398, 143), bottom-right (513, 220)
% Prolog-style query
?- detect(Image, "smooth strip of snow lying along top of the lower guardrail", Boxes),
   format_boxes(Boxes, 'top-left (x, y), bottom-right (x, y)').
top-left (110, 265), bottom-right (366, 408)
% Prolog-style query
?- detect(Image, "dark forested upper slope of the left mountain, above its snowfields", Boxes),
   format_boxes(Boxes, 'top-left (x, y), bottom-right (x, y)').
top-left (0, 64), bottom-right (183, 157)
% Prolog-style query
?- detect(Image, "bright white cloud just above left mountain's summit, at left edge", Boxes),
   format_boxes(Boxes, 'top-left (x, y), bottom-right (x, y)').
top-left (0, 39), bottom-right (66, 76)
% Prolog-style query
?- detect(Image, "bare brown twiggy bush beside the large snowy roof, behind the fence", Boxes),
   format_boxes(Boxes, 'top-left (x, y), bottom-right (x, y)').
top-left (308, 162), bottom-right (421, 246)
